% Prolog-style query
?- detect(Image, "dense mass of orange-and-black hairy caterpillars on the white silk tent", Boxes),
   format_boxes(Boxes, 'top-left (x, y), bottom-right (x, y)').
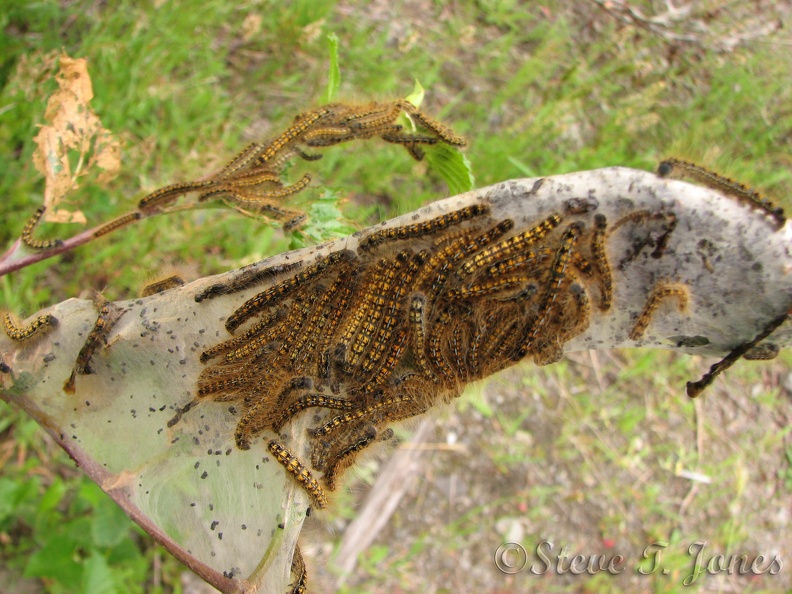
top-left (183, 194), bottom-right (708, 508)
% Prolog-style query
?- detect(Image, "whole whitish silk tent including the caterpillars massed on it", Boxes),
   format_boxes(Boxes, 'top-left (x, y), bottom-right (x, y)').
top-left (0, 168), bottom-right (792, 592)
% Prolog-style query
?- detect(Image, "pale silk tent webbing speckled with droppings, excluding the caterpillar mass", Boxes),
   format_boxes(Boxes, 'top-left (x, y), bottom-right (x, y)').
top-left (0, 168), bottom-right (792, 592)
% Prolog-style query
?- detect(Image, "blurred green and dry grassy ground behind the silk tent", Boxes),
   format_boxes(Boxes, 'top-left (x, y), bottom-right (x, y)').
top-left (0, 0), bottom-right (792, 592)
